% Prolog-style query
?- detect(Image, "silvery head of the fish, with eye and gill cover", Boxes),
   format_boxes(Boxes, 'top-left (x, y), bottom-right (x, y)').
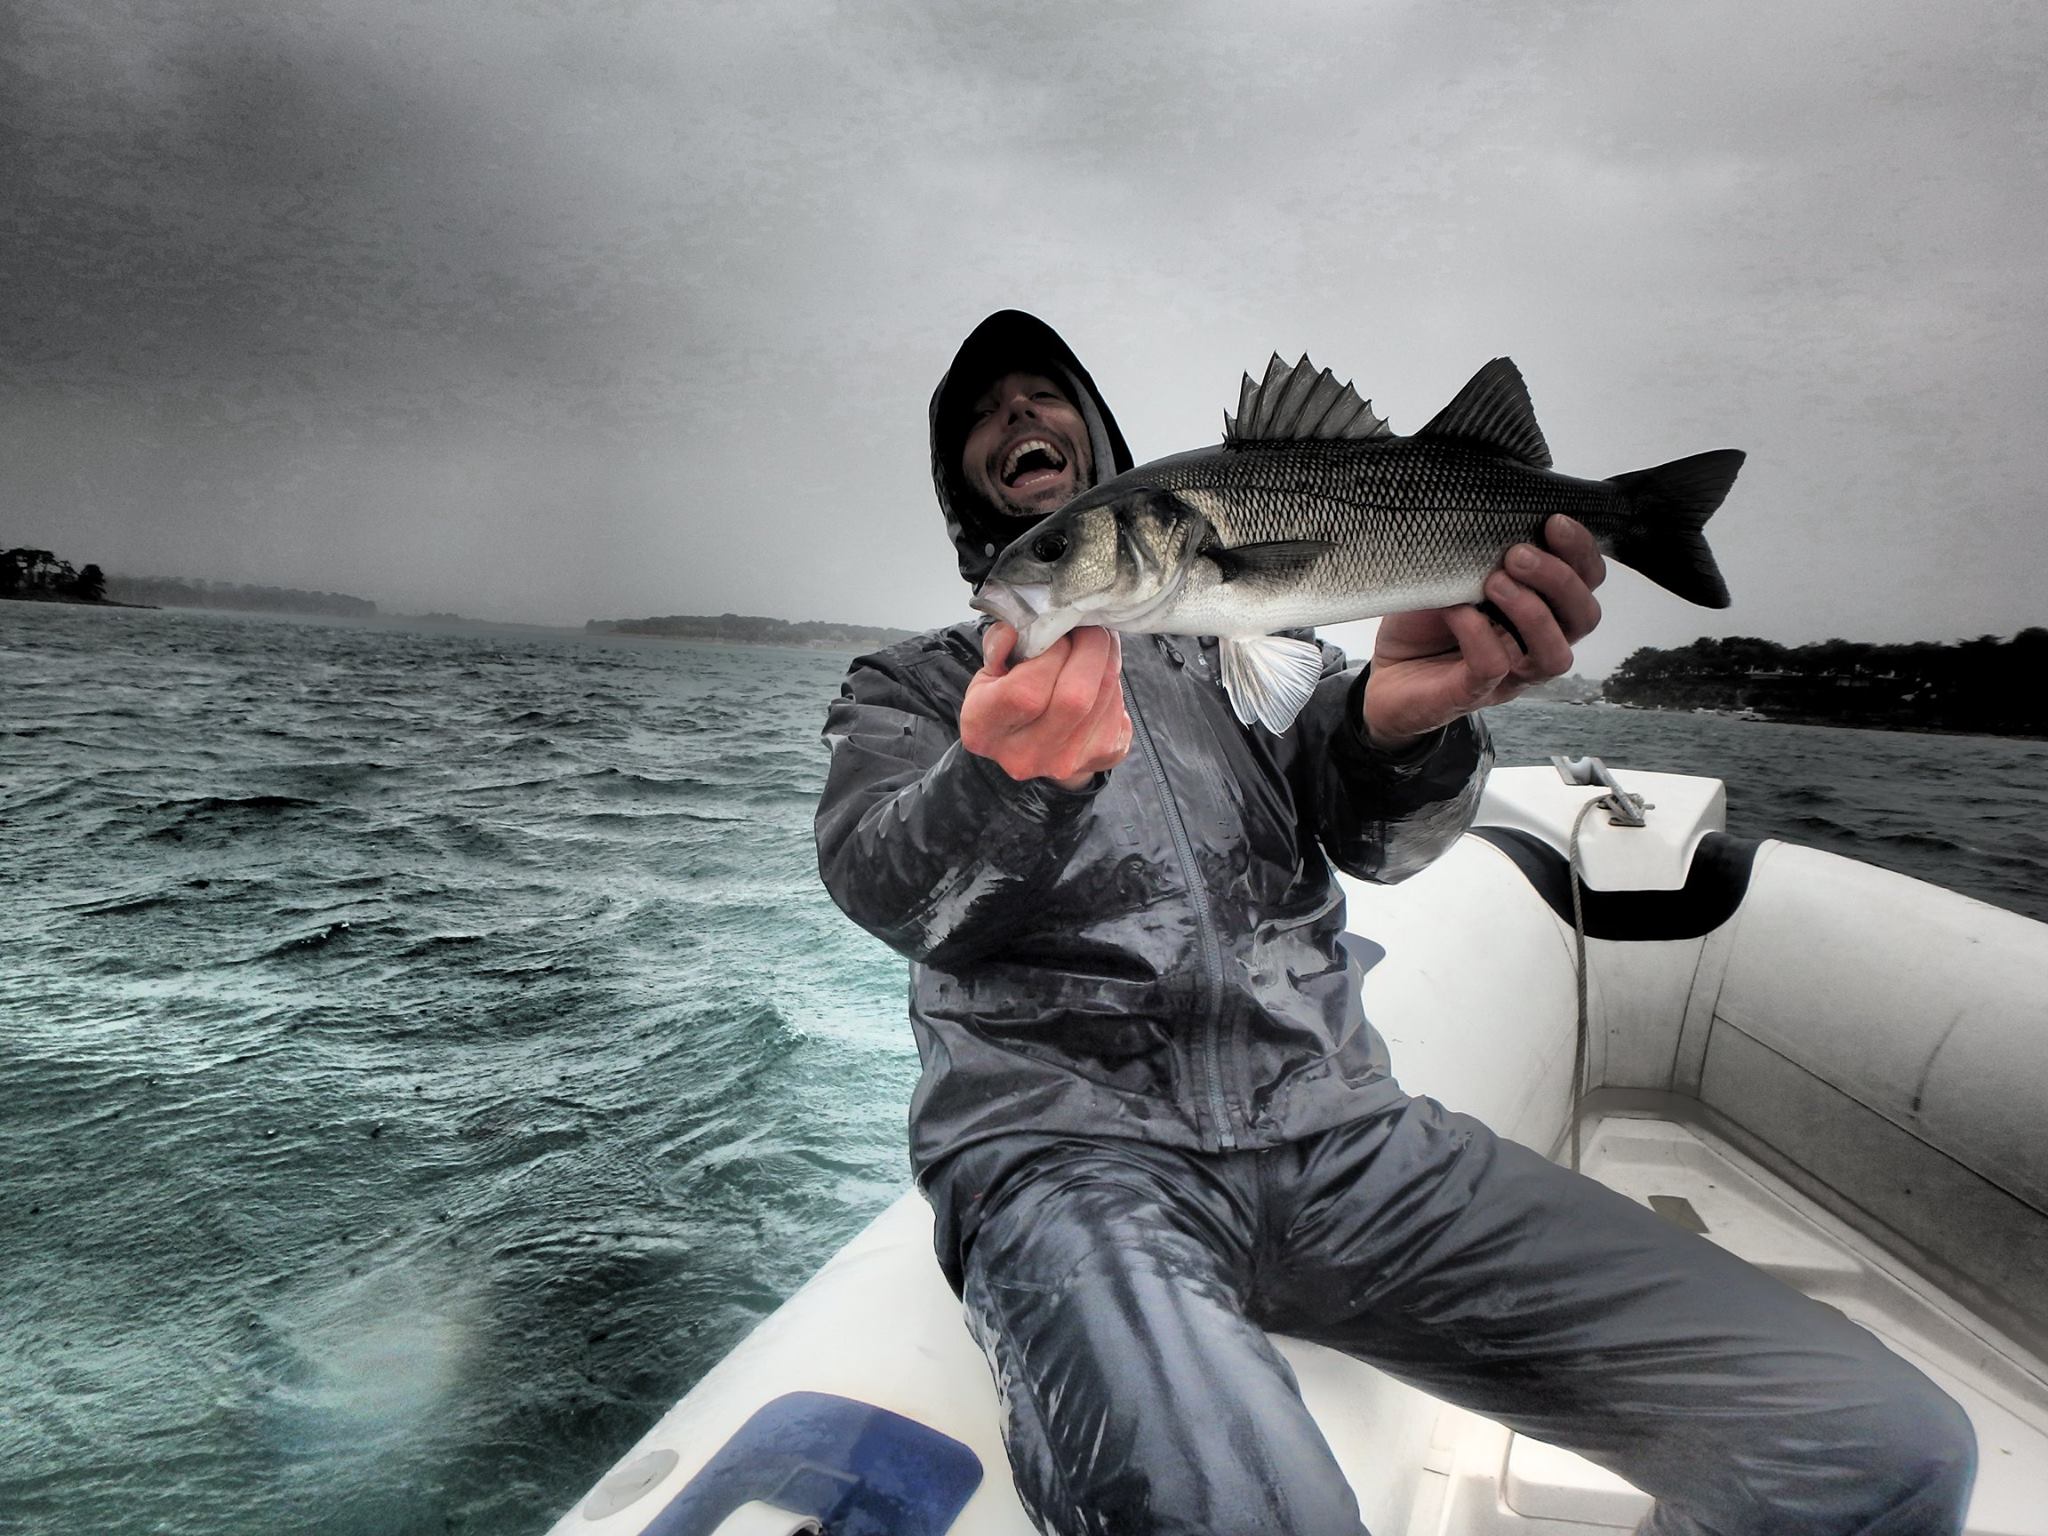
top-left (973, 485), bottom-right (1206, 657)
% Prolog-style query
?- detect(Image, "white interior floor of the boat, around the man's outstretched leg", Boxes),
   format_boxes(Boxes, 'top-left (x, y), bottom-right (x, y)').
top-left (1407, 1112), bottom-right (2048, 1536)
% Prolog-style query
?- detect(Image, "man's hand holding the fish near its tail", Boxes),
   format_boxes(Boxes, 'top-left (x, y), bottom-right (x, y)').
top-left (1366, 516), bottom-right (1608, 752)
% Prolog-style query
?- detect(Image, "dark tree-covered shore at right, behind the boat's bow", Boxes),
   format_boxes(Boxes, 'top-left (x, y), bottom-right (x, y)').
top-left (1606, 627), bottom-right (2048, 735)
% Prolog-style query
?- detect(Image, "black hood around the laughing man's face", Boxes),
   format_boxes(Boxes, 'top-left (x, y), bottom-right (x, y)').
top-left (932, 309), bottom-right (1130, 584)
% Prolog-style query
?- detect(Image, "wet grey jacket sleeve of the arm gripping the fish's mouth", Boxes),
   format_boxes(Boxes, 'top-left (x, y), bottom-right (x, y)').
top-left (817, 645), bottom-right (1102, 969)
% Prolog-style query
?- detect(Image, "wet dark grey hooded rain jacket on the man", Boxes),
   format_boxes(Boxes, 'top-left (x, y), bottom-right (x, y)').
top-left (817, 311), bottom-right (1491, 1178)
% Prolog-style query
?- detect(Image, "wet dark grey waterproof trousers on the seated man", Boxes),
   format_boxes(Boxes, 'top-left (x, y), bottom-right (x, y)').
top-left (928, 1098), bottom-right (1976, 1536)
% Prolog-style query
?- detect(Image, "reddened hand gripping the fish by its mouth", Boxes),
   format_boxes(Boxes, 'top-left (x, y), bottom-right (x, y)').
top-left (961, 623), bottom-right (1130, 788)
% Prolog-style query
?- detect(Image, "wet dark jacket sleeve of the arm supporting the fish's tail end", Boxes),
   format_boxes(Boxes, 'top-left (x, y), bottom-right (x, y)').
top-left (1290, 641), bottom-right (1493, 885)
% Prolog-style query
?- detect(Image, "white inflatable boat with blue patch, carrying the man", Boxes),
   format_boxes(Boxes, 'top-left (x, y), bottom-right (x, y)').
top-left (553, 758), bottom-right (2048, 1536)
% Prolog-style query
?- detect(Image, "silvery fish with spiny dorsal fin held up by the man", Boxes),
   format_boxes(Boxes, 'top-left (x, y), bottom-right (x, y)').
top-left (973, 354), bottom-right (1745, 733)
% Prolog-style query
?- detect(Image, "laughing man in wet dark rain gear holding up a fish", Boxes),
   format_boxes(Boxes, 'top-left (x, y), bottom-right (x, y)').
top-left (817, 311), bottom-right (1974, 1536)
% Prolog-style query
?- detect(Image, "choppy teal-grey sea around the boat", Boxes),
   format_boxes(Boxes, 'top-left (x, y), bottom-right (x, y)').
top-left (12, 602), bottom-right (2048, 1536)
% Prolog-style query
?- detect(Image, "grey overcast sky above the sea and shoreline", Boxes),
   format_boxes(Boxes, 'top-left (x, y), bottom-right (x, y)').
top-left (0, 0), bottom-right (2048, 672)
